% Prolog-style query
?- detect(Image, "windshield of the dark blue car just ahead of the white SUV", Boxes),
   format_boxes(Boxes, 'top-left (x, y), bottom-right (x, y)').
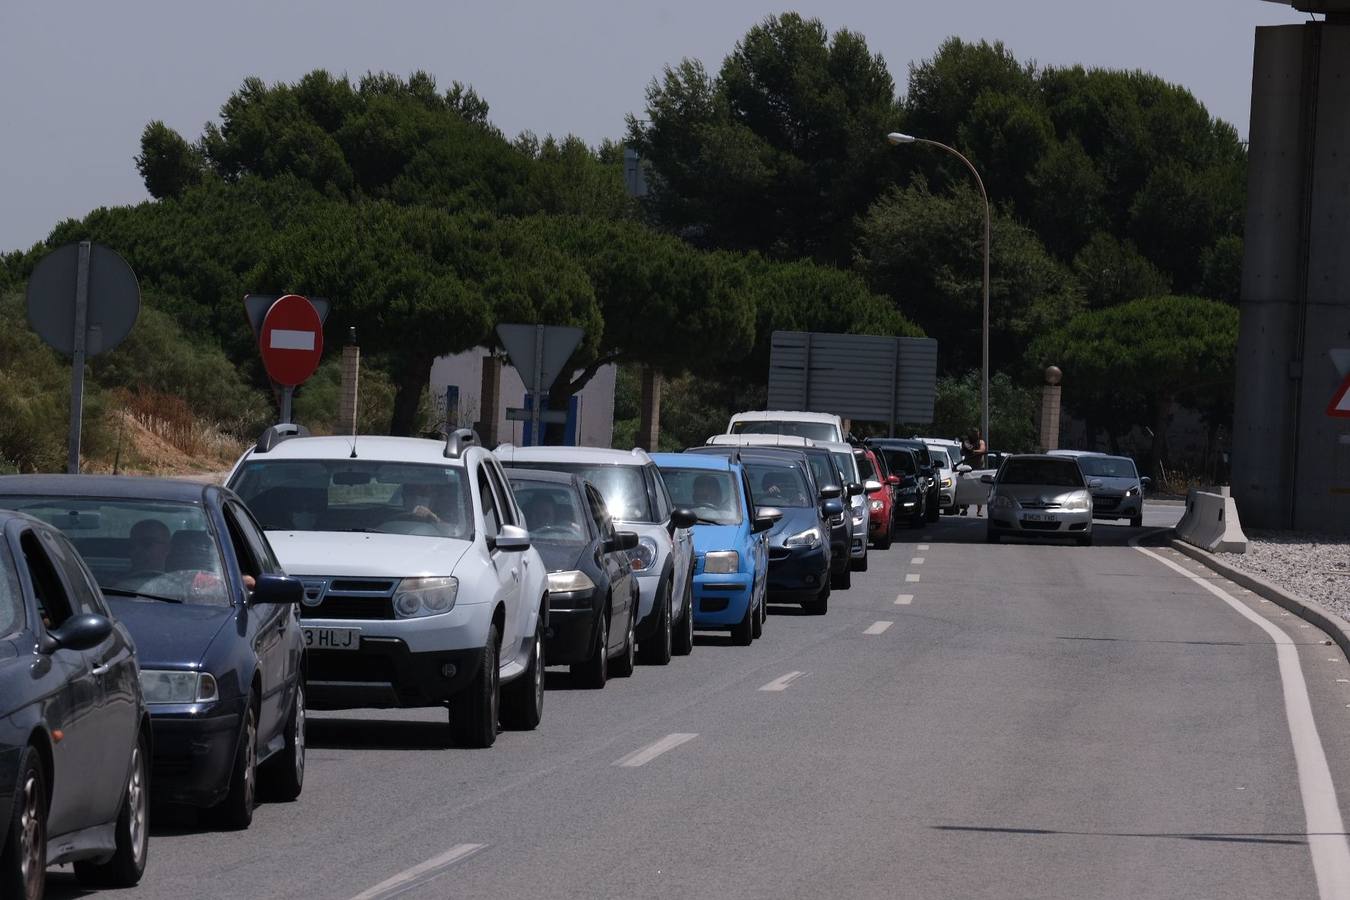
top-left (0, 497), bottom-right (231, 609)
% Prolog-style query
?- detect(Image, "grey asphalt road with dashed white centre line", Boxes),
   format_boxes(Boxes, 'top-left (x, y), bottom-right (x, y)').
top-left (50, 507), bottom-right (1350, 900)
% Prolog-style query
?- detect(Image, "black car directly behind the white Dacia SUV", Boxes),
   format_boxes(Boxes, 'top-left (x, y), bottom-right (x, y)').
top-left (508, 468), bottom-right (639, 688)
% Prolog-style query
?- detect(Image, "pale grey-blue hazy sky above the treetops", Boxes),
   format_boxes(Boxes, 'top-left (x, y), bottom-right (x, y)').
top-left (0, 0), bottom-right (1307, 252)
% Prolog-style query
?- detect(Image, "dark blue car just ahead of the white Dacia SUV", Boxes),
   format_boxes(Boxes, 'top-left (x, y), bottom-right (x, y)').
top-left (0, 475), bottom-right (305, 827)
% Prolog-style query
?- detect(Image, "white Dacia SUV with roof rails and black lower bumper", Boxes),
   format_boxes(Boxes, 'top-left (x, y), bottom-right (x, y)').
top-left (228, 426), bottom-right (548, 746)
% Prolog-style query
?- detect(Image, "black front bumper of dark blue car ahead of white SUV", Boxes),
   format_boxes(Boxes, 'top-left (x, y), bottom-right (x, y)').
top-left (150, 707), bottom-right (240, 807)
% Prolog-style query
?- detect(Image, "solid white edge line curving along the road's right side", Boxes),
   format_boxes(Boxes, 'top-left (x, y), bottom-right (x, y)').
top-left (1130, 536), bottom-right (1350, 900)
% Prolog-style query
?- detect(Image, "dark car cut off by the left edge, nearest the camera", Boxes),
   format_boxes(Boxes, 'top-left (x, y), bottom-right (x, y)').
top-left (0, 511), bottom-right (151, 900)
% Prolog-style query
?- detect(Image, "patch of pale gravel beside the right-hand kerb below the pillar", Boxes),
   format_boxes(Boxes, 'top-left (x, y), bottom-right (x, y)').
top-left (1223, 530), bottom-right (1350, 619)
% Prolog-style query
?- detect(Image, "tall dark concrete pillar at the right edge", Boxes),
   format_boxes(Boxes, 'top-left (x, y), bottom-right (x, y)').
top-left (1231, 16), bottom-right (1350, 532)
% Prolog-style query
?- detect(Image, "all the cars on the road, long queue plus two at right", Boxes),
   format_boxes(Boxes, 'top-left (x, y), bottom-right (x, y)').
top-left (0, 412), bottom-right (1146, 899)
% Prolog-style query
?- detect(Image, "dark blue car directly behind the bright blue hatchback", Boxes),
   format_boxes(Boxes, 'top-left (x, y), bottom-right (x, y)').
top-left (684, 444), bottom-right (848, 615)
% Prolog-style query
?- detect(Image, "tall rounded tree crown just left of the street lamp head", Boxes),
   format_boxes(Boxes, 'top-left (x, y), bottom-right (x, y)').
top-left (629, 13), bottom-right (899, 263)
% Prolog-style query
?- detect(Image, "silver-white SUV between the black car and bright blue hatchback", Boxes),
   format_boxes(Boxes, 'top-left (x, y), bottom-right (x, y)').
top-left (494, 444), bottom-right (697, 665)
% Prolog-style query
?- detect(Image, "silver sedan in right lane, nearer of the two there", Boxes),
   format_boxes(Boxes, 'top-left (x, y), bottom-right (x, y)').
top-left (980, 456), bottom-right (1092, 545)
